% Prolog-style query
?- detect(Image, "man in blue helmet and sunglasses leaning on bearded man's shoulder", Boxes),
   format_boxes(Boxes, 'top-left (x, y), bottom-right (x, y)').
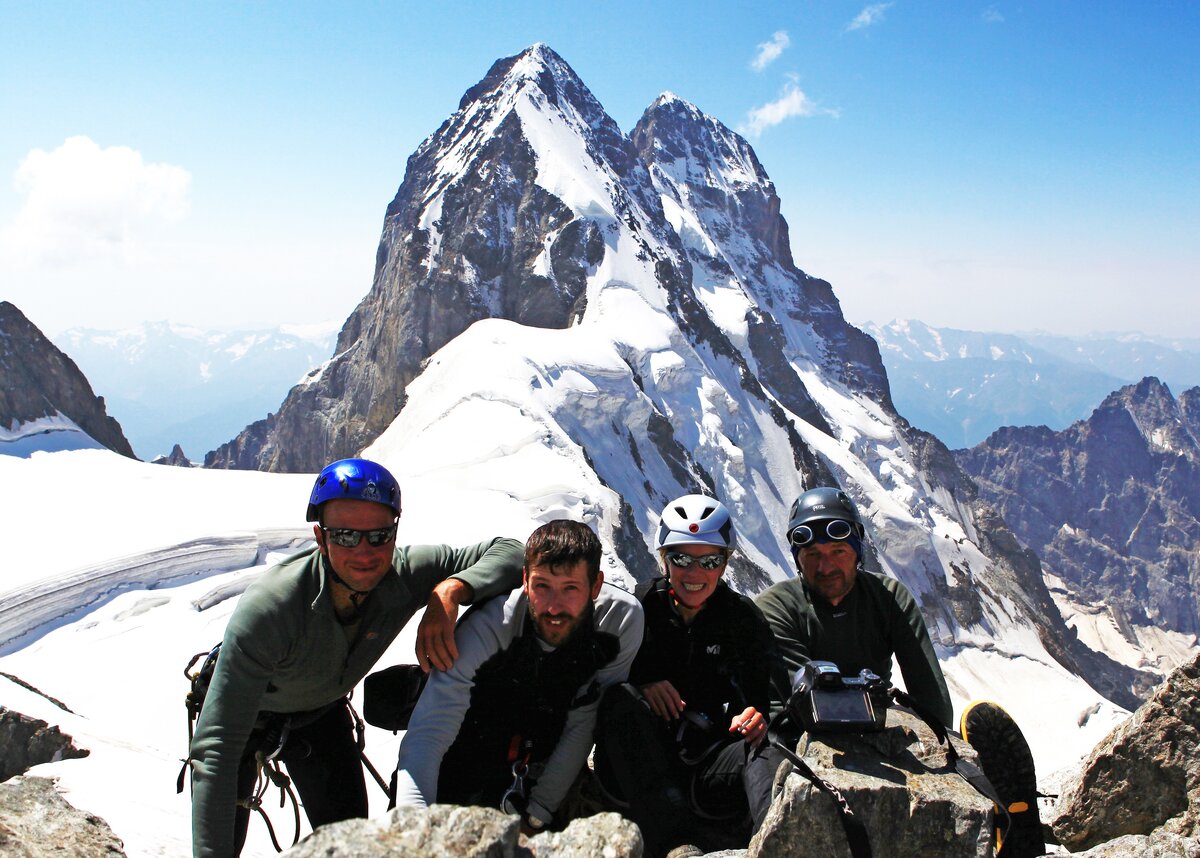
top-left (190, 458), bottom-right (523, 856)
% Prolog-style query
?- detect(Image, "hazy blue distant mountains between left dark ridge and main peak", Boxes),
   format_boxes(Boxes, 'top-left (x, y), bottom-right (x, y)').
top-left (54, 322), bottom-right (337, 461)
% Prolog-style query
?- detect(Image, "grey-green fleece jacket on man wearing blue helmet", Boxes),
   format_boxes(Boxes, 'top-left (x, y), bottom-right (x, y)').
top-left (191, 539), bottom-right (524, 858)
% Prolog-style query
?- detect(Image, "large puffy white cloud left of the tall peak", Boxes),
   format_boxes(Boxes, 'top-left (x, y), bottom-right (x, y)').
top-left (0, 137), bottom-right (192, 268)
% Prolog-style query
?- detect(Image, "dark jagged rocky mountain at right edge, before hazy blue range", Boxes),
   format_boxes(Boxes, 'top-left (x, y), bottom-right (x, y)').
top-left (956, 378), bottom-right (1200, 635)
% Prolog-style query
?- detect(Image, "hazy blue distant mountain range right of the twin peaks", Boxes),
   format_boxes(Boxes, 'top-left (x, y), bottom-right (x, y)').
top-left (860, 319), bottom-right (1200, 448)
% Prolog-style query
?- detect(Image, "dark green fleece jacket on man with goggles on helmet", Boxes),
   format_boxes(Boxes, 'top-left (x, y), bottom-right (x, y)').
top-left (755, 571), bottom-right (954, 726)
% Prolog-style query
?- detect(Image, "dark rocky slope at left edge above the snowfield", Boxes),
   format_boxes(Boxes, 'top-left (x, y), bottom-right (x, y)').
top-left (0, 301), bottom-right (134, 458)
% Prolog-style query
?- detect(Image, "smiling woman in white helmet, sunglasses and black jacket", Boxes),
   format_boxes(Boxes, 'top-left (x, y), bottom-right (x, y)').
top-left (596, 494), bottom-right (774, 854)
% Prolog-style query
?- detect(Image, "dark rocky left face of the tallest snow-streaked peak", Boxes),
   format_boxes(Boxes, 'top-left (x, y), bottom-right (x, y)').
top-left (212, 46), bottom-right (644, 472)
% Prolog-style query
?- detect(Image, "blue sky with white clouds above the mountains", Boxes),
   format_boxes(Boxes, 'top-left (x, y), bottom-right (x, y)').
top-left (0, 0), bottom-right (1200, 336)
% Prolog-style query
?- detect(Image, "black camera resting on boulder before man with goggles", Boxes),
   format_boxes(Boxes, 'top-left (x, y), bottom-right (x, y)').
top-left (787, 661), bottom-right (889, 733)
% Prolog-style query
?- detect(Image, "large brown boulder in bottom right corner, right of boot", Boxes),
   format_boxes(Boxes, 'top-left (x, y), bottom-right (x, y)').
top-left (1052, 655), bottom-right (1200, 854)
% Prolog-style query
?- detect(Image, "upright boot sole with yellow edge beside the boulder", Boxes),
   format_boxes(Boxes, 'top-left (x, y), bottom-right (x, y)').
top-left (959, 701), bottom-right (1045, 858)
